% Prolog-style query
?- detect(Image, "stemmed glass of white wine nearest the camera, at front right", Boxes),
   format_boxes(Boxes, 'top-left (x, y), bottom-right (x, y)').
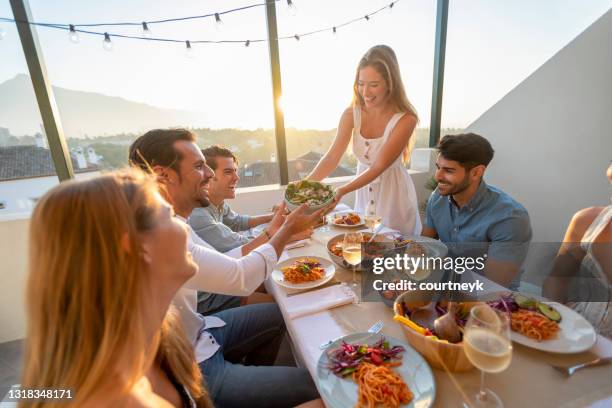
top-left (463, 304), bottom-right (512, 408)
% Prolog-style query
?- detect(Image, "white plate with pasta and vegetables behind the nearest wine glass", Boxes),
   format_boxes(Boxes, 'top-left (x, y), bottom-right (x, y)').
top-left (487, 293), bottom-right (597, 354)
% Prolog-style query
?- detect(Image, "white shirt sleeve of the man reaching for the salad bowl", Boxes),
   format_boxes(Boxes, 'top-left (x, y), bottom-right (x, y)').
top-left (185, 240), bottom-right (277, 296)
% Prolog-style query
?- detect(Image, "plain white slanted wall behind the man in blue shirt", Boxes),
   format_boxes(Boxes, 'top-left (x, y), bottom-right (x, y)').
top-left (468, 11), bottom-right (612, 242)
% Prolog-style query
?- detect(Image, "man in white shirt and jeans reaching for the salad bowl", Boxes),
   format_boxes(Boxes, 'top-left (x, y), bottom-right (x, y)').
top-left (129, 129), bottom-right (325, 408)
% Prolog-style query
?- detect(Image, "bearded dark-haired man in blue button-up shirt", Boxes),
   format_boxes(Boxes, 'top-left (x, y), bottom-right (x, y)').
top-left (423, 133), bottom-right (532, 289)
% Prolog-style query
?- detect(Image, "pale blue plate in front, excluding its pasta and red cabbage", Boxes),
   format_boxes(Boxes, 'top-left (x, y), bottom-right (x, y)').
top-left (317, 333), bottom-right (436, 408)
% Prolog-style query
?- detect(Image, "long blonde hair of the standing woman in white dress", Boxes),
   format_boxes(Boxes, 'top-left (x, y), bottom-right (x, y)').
top-left (353, 45), bottom-right (419, 162)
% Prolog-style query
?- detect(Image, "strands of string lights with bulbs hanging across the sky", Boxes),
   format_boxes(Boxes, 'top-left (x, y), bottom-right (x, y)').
top-left (0, 0), bottom-right (401, 51)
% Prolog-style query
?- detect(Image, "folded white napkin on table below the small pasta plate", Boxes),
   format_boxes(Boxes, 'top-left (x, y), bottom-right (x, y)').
top-left (286, 283), bottom-right (357, 319)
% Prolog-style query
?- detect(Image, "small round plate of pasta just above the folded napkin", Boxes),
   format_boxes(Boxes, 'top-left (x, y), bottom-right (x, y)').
top-left (272, 256), bottom-right (336, 289)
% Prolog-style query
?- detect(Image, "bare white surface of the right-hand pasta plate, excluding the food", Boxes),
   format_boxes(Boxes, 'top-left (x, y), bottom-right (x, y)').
top-left (510, 302), bottom-right (597, 354)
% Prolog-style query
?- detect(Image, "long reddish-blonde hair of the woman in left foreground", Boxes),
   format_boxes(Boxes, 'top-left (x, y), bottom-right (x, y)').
top-left (21, 170), bottom-right (208, 407)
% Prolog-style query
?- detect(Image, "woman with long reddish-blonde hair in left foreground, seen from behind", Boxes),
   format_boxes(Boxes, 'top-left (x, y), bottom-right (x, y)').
top-left (19, 171), bottom-right (212, 407)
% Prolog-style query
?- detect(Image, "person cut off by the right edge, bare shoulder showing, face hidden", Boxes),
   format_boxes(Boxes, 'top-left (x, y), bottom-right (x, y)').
top-left (542, 162), bottom-right (612, 338)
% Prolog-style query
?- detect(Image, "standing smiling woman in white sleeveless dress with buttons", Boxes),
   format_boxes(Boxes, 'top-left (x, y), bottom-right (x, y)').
top-left (308, 45), bottom-right (421, 235)
